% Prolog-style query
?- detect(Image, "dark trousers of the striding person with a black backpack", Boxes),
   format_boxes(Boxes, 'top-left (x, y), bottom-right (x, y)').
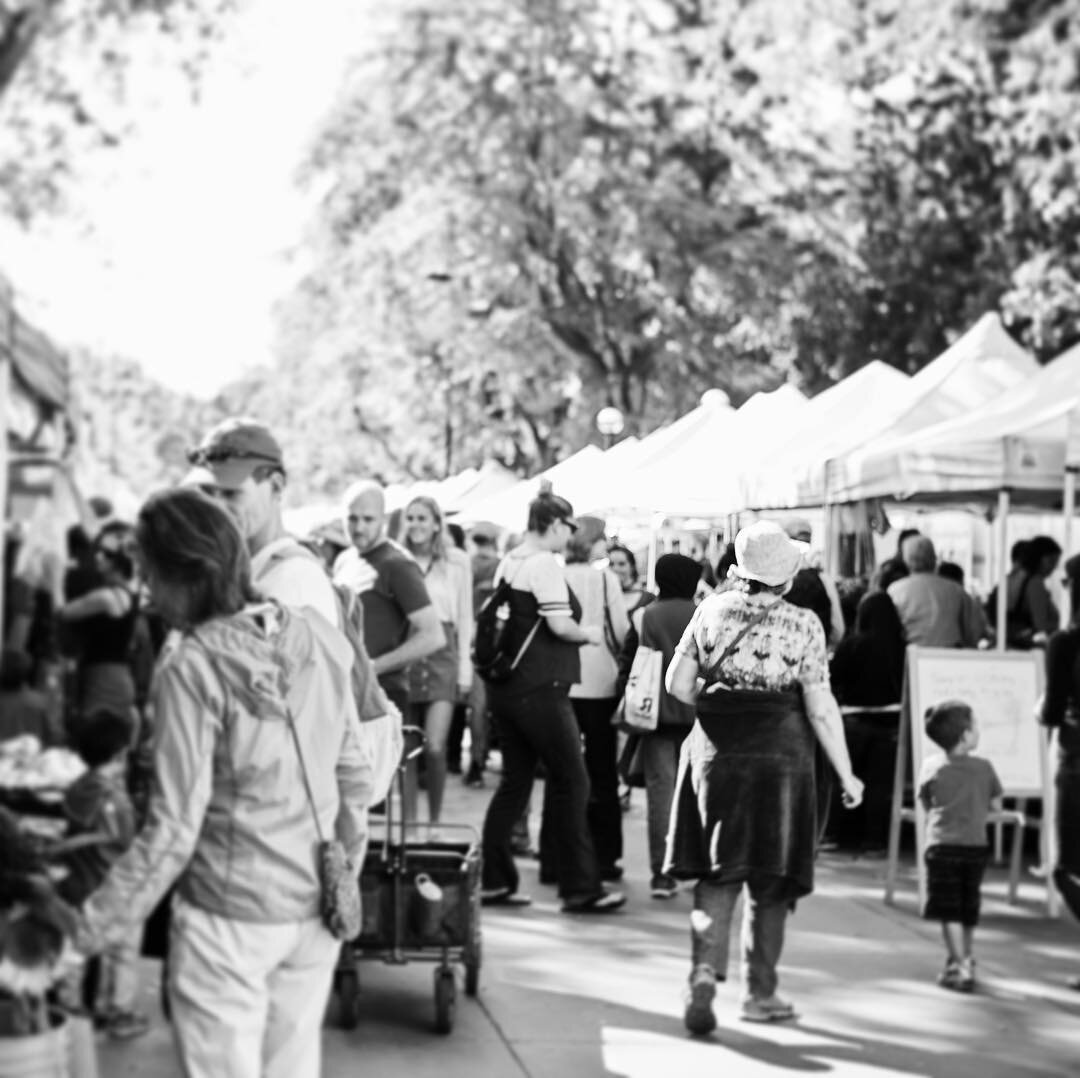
top-left (483, 687), bottom-right (602, 899)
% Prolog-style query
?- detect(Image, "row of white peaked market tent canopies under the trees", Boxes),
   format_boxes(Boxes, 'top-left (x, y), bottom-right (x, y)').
top-left (430, 313), bottom-right (1080, 529)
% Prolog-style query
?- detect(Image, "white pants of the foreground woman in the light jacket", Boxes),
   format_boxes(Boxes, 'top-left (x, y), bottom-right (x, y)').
top-left (168, 900), bottom-right (341, 1078)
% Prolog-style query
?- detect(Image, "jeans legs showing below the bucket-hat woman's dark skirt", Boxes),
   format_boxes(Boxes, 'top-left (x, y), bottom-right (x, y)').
top-left (690, 873), bottom-right (791, 999)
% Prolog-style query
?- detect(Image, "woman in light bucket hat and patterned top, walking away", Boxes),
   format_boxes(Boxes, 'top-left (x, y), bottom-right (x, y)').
top-left (664, 521), bottom-right (863, 1035)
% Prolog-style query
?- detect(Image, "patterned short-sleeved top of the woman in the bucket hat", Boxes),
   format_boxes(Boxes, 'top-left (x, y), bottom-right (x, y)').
top-left (677, 590), bottom-right (829, 691)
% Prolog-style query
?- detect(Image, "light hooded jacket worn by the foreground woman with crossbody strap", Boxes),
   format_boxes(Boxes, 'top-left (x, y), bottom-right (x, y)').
top-left (84, 603), bottom-right (373, 943)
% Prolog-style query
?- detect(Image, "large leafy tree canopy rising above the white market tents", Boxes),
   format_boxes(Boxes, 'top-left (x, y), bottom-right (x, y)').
top-left (54, 0), bottom-right (1080, 491)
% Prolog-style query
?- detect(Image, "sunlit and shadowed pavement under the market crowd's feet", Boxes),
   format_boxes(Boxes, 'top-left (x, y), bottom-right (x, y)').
top-left (98, 773), bottom-right (1080, 1078)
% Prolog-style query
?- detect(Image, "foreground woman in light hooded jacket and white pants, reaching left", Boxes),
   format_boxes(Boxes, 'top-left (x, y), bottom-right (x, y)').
top-left (78, 489), bottom-right (372, 1078)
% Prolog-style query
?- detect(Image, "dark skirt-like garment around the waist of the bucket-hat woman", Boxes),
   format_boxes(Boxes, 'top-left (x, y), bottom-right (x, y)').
top-left (663, 689), bottom-right (818, 900)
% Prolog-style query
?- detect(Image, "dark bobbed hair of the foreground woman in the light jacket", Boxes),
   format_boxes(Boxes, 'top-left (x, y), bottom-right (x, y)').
top-left (135, 487), bottom-right (256, 624)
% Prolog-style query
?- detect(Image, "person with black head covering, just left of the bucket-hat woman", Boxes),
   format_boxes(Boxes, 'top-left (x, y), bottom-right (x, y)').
top-left (616, 554), bottom-right (701, 899)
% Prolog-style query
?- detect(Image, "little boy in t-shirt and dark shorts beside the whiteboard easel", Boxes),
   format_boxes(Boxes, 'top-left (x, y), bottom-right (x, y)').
top-left (919, 700), bottom-right (1001, 992)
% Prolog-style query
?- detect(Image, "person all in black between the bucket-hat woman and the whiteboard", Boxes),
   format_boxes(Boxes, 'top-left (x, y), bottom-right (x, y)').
top-left (829, 592), bottom-right (904, 853)
